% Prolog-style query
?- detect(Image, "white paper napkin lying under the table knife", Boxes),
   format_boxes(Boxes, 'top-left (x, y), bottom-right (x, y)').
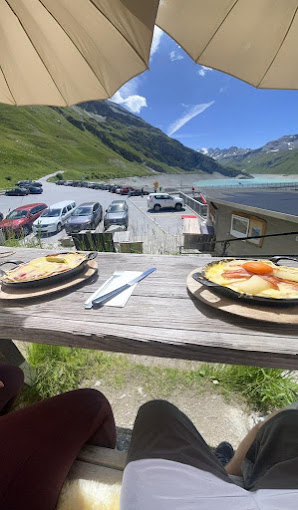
top-left (85, 271), bottom-right (142, 308)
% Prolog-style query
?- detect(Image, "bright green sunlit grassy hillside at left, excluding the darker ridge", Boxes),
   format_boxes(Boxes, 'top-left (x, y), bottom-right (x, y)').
top-left (0, 105), bottom-right (149, 188)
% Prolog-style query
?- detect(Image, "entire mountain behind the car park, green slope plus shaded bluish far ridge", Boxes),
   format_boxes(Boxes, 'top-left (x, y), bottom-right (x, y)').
top-left (0, 101), bottom-right (237, 188)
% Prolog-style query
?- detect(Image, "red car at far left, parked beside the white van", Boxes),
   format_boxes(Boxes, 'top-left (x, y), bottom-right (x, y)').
top-left (0, 204), bottom-right (48, 236)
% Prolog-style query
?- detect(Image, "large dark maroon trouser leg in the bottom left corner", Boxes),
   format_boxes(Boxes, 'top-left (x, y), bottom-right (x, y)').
top-left (0, 390), bottom-right (116, 510)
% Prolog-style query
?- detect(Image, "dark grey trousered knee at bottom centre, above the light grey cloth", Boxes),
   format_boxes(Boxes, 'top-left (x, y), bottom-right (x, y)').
top-left (127, 400), bottom-right (230, 482)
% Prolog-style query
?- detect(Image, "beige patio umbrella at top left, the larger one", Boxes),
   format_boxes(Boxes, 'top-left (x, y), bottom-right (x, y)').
top-left (0, 0), bottom-right (158, 106)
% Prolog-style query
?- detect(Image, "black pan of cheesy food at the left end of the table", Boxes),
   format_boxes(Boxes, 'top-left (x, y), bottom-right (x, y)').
top-left (2, 252), bottom-right (97, 288)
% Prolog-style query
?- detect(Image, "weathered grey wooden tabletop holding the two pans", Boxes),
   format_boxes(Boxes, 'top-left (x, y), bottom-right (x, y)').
top-left (0, 247), bottom-right (298, 369)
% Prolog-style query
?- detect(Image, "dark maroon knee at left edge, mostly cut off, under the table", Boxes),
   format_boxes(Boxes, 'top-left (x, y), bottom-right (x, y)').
top-left (0, 365), bottom-right (24, 416)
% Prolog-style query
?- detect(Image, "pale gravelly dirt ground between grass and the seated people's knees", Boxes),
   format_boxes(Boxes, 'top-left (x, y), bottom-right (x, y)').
top-left (89, 355), bottom-right (256, 447)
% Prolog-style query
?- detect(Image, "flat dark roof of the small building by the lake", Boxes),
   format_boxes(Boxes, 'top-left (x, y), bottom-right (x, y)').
top-left (206, 189), bottom-right (298, 222)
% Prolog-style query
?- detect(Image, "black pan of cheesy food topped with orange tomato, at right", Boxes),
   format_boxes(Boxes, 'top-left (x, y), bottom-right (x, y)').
top-left (192, 257), bottom-right (298, 306)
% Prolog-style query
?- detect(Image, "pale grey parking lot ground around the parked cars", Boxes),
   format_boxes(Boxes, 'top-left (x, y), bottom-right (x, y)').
top-left (0, 178), bottom-right (193, 252)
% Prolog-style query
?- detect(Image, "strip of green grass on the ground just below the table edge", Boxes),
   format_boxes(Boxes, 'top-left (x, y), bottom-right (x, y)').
top-left (17, 344), bottom-right (298, 413)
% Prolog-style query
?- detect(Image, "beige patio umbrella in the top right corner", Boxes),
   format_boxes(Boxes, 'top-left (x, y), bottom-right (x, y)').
top-left (157, 0), bottom-right (298, 89)
